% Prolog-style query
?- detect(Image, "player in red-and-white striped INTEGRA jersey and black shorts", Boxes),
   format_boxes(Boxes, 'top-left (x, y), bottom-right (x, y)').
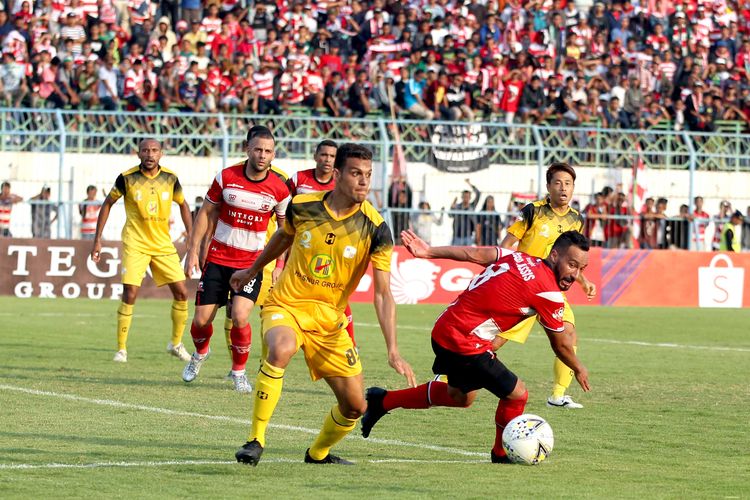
top-left (182, 126), bottom-right (291, 393)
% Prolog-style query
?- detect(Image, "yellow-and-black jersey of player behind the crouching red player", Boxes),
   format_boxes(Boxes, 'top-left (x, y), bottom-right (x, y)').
top-left (508, 198), bottom-right (583, 259)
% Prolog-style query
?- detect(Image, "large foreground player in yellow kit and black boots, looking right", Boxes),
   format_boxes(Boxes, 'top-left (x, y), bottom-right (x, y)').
top-left (231, 144), bottom-right (416, 465)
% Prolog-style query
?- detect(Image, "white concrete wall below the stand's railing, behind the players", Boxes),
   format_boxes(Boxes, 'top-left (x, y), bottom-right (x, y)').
top-left (0, 152), bottom-right (750, 239)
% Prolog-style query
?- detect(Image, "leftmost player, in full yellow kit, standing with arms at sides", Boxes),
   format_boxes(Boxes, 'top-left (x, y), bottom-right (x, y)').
top-left (91, 139), bottom-right (192, 363)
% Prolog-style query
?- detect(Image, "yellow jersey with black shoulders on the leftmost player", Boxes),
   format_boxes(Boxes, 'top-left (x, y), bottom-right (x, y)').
top-left (109, 166), bottom-right (185, 255)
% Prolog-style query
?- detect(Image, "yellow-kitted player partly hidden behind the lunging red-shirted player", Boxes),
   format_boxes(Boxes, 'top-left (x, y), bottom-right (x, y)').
top-left (497, 163), bottom-right (596, 408)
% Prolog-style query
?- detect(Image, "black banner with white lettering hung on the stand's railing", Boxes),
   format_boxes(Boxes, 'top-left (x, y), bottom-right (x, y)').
top-left (429, 123), bottom-right (490, 172)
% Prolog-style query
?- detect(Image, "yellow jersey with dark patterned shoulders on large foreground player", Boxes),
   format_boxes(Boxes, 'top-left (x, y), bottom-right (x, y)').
top-left (265, 191), bottom-right (393, 332)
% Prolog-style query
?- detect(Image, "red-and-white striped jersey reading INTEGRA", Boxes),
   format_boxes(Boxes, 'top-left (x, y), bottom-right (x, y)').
top-left (206, 161), bottom-right (291, 269)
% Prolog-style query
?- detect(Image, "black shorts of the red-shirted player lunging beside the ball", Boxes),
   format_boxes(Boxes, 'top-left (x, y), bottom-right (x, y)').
top-left (432, 339), bottom-right (518, 398)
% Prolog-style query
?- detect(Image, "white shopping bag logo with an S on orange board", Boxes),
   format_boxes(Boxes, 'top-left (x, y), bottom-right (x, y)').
top-left (698, 253), bottom-right (745, 307)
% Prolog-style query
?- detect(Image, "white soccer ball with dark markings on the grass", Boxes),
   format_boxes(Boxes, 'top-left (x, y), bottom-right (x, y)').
top-left (503, 413), bottom-right (555, 465)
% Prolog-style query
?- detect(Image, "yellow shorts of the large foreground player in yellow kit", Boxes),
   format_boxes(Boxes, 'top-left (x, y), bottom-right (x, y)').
top-left (260, 304), bottom-right (362, 381)
